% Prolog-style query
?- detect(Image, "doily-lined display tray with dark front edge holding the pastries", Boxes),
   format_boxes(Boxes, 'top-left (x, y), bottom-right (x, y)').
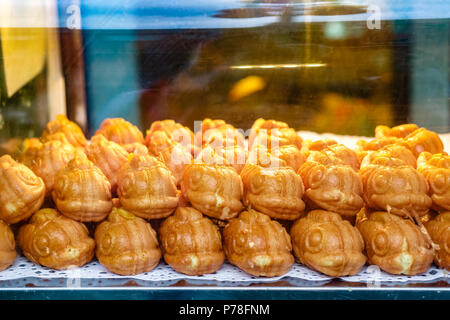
top-left (0, 131), bottom-right (450, 300)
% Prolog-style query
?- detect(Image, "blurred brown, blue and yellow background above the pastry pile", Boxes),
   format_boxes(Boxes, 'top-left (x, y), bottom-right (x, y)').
top-left (0, 0), bottom-right (450, 152)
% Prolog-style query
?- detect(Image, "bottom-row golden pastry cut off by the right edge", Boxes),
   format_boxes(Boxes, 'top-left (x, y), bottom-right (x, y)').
top-left (425, 211), bottom-right (450, 270)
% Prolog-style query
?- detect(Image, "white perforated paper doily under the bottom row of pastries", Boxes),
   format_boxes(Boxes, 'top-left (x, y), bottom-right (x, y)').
top-left (0, 256), bottom-right (449, 283)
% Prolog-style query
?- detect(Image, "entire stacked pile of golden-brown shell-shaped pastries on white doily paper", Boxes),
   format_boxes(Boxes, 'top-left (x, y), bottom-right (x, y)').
top-left (0, 116), bottom-right (450, 277)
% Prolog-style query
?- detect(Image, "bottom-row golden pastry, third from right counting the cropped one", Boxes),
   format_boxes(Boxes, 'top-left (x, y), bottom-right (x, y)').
top-left (290, 210), bottom-right (367, 277)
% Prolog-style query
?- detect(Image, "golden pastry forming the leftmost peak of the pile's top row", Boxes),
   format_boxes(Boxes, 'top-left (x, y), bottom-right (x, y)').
top-left (41, 114), bottom-right (87, 148)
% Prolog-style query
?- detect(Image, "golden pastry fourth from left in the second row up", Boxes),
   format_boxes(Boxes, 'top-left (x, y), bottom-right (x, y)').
top-left (181, 163), bottom-right (243, 220)
